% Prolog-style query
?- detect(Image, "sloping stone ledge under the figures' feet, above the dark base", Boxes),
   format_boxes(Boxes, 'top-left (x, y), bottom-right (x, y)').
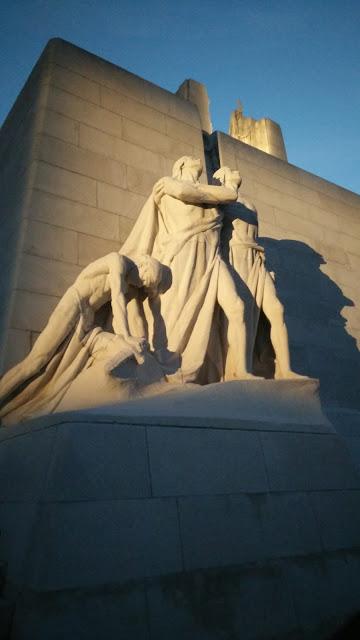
top-left (0, 378), bottom-right (335, 441)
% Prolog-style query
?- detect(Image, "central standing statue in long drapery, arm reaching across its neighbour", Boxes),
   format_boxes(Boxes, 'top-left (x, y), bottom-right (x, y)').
top-left (122, 156), bottom-right (251, 383)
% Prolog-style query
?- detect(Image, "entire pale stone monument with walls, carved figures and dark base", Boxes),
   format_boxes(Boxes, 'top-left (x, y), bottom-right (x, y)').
top-left (0, 40), bottom-right (360, 640)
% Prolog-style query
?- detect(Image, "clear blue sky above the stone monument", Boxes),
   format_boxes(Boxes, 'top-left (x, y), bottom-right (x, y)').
top-left (0, 0), bottom-right (360, 193)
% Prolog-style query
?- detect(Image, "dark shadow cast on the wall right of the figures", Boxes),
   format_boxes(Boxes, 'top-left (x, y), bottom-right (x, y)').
top-left (259, 237), bottom-right (360, 407)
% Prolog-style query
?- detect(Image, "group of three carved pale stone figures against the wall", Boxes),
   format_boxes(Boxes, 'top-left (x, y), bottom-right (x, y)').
top-left (0, 156), bottom-right (301, 424)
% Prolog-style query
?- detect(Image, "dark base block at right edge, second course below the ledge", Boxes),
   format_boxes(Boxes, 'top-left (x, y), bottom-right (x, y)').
top-left (310, 491), bottom-right (360, 551)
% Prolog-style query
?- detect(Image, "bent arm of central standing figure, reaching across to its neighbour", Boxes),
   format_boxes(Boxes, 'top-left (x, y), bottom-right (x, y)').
top-left (153, 177), bottom-right (237, 205)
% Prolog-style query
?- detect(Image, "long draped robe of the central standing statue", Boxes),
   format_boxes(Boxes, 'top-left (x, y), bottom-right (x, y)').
top-left (120, 190), bottom-right (222, 382)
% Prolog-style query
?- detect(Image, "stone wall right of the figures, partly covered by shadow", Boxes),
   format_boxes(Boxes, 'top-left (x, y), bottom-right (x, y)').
top-left (217, 133), bottom-right (360, 406)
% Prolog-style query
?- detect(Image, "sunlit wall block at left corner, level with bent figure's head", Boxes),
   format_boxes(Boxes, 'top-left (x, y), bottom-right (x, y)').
top-left (18, 254), bottom-right (81, 296)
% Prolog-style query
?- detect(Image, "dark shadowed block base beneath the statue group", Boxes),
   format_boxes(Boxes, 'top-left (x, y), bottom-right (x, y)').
top-left (0, 381), bottom-right (360, 640)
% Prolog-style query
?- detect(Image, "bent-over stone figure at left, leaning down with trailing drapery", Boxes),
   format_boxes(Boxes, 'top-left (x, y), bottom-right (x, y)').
top-left (0, 252), bottom-right (171, 423)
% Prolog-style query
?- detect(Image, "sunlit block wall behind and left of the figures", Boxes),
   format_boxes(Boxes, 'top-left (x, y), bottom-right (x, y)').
top-left (0, 39), bottom-right (203, 368)
